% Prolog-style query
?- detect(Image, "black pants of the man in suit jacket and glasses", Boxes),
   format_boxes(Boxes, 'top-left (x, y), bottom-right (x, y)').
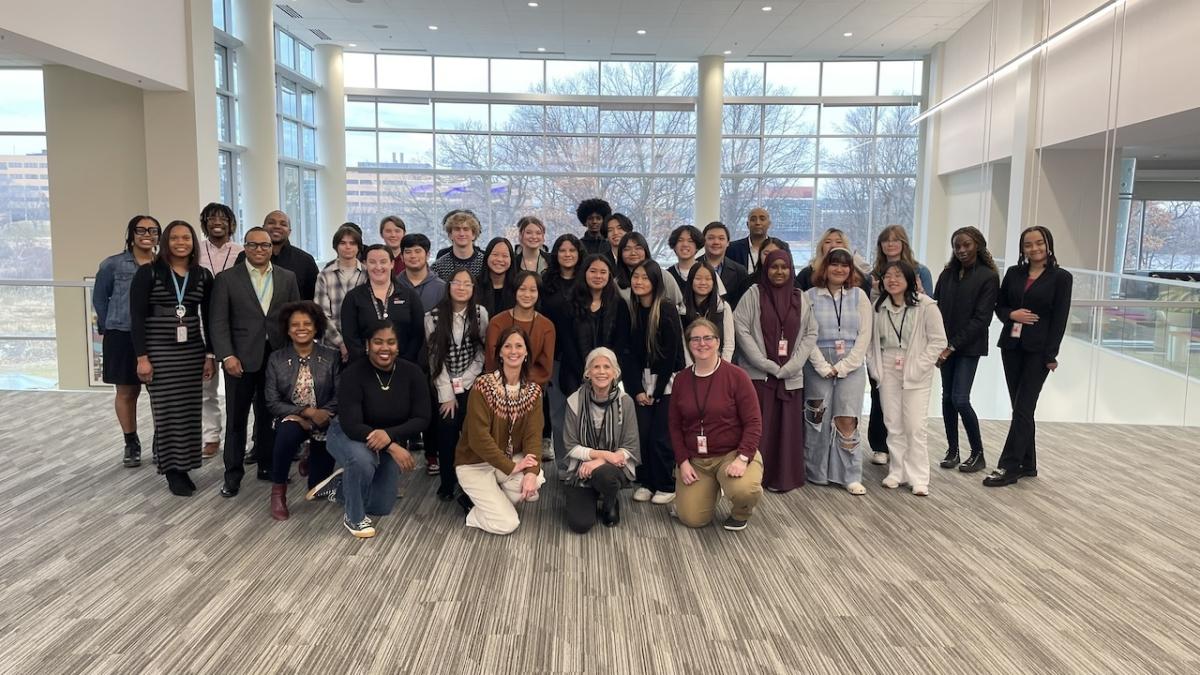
top-left (224, 358), bottom-right (275, 488)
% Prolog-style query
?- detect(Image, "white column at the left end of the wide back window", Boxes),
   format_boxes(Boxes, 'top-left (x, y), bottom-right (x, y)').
top-left (313, 44), bottom-right (346, 245)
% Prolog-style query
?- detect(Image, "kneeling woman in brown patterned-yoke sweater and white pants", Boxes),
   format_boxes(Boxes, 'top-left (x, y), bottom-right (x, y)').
top-left (455, 325), bottom-right (546, 534)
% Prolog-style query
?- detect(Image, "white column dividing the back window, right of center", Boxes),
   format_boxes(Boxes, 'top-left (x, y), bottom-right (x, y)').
top-left (695, 56), bottom-right (725, 227)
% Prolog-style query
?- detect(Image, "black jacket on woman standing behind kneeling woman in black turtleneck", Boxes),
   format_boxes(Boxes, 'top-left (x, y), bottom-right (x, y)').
top-left (342, 277), bottom-right (425, 364)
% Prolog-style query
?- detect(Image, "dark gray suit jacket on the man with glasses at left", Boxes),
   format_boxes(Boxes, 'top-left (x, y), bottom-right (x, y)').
top-left (209, 264), bottom-right (300, 372)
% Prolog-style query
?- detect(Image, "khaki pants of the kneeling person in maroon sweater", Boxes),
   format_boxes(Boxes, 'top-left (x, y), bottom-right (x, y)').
top-left (674, 450), bottom-right (762, 527)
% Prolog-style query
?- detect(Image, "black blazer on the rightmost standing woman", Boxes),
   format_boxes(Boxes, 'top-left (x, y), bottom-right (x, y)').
top-left (996, 265), bottom-right (1074, 363)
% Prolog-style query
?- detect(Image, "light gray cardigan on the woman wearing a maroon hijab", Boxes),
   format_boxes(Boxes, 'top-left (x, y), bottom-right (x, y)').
top-left (733, 283), bottom-right (818, 389)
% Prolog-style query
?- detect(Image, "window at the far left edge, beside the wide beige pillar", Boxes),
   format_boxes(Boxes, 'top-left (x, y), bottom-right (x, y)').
top-left (0, 68), bottom-right (55, 389)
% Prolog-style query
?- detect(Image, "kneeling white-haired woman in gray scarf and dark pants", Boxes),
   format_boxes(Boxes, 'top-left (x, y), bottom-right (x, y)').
top-left (563, 347), bottom-right (641, 534)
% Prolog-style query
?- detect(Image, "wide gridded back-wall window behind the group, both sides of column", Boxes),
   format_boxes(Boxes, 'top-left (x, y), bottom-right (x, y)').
top-left (343, 53), bottom-right (922, 259)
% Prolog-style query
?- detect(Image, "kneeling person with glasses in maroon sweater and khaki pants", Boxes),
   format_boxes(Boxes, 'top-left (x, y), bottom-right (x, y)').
top-left (670, 318), bottom-right (762, 530)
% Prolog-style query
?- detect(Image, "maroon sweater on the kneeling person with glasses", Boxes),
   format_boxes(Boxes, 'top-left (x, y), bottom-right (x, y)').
top-left (671, 360), bottom-right (762, 464)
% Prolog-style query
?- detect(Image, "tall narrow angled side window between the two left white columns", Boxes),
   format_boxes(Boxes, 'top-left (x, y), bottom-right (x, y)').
top-left (275, 26), bottom-right (322, 251)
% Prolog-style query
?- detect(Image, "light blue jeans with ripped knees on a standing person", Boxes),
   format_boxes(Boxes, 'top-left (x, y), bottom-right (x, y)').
top-left (804, 350), bottom-right (866, 485)
